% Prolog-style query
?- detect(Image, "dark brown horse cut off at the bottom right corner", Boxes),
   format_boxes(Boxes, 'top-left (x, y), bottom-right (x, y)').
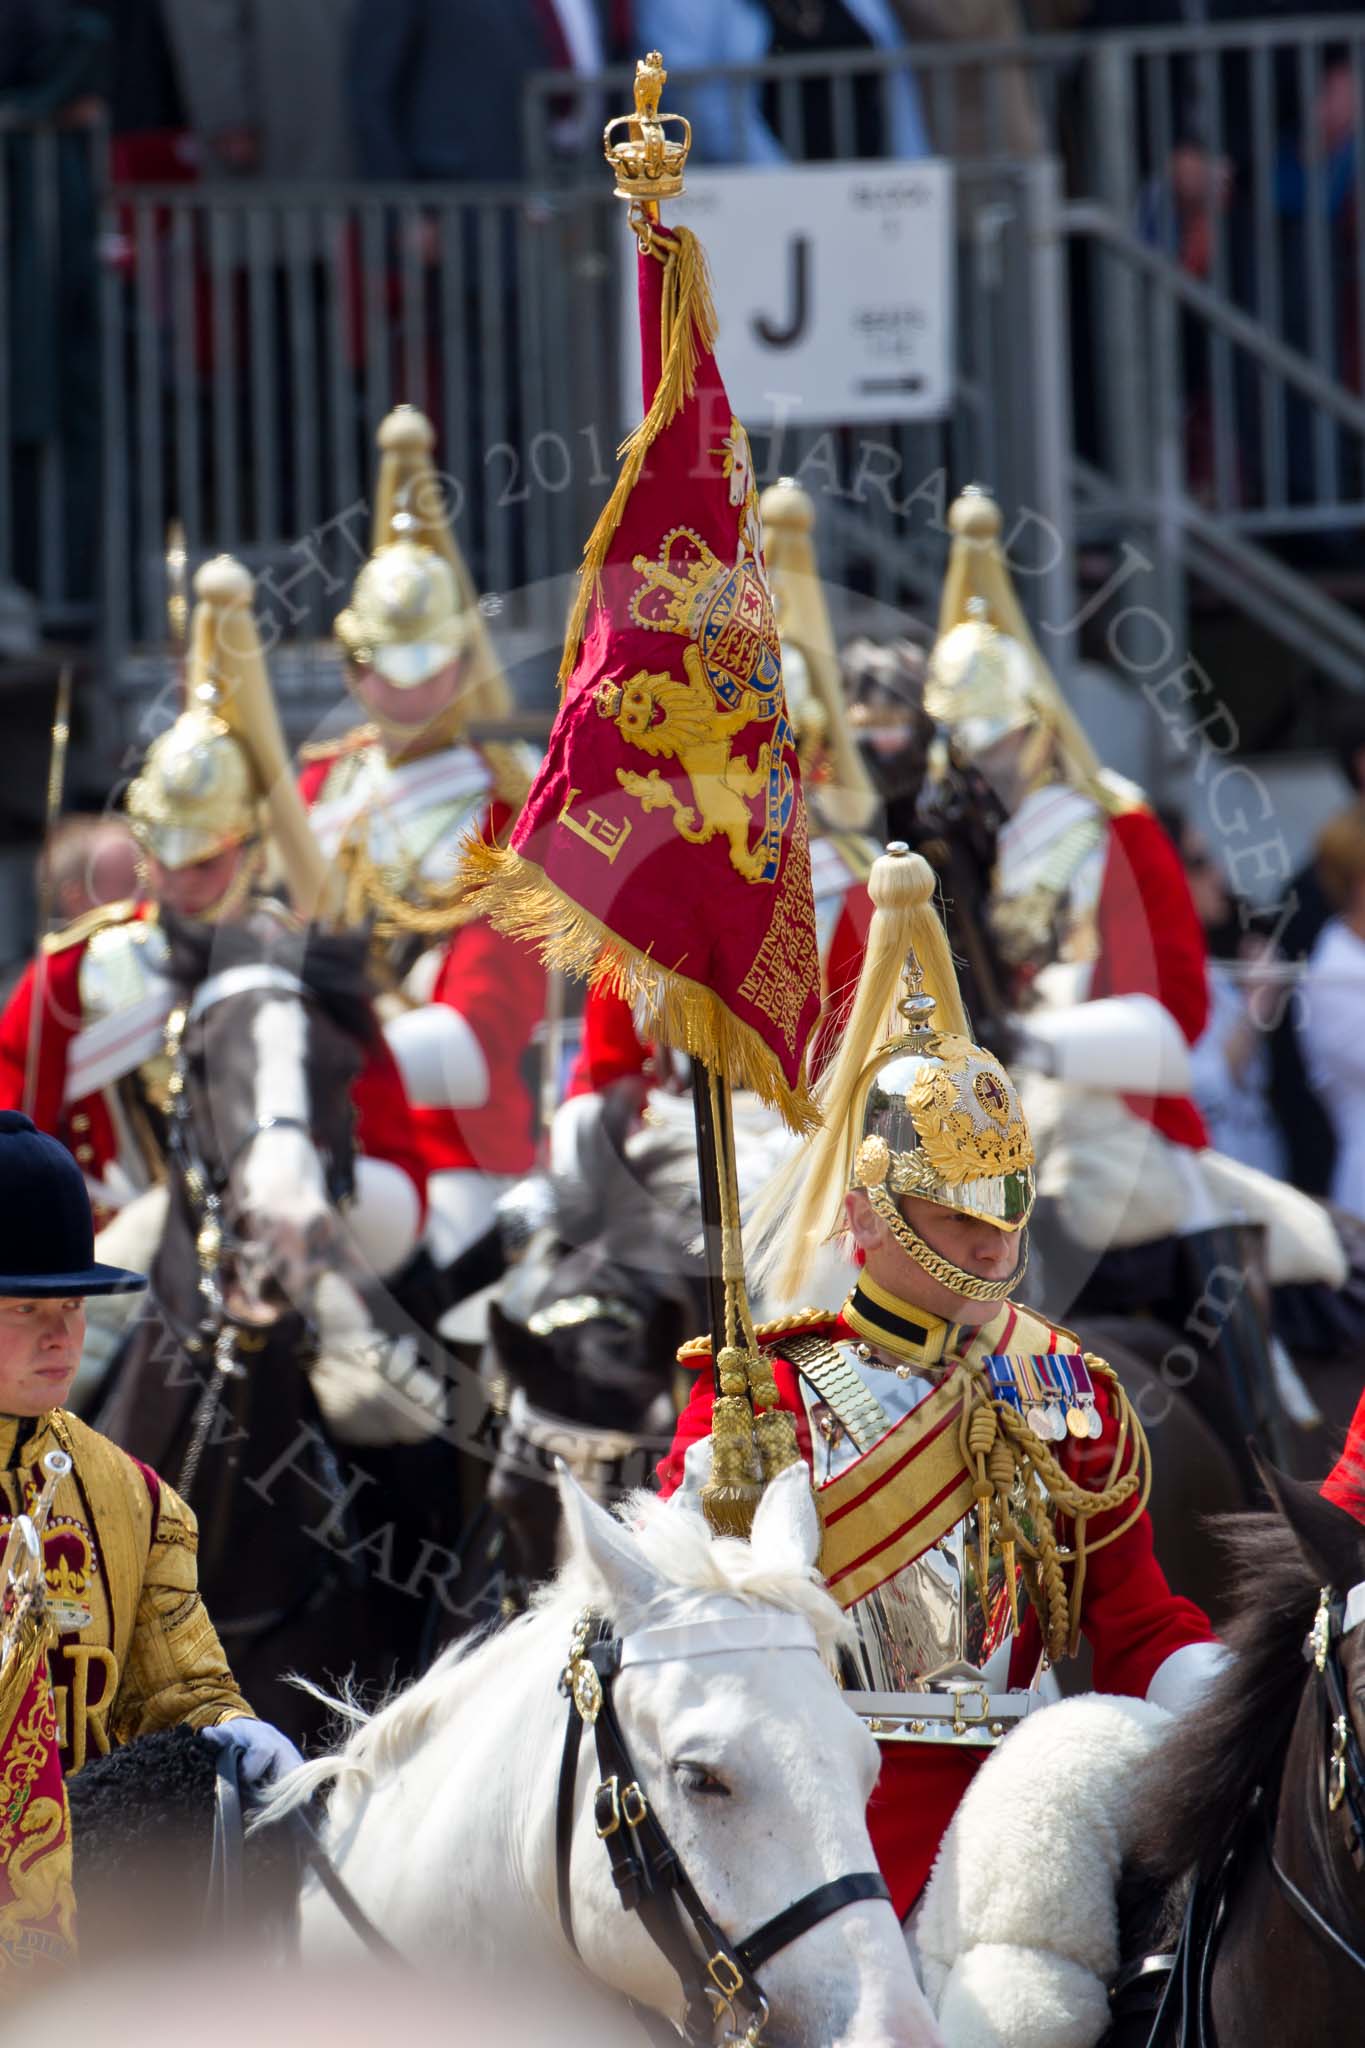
top-left (1107, 1477), bottom-right (1365, 2048)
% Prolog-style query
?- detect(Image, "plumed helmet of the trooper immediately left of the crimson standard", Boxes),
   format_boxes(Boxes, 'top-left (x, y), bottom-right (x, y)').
top-left (336, 406), bottom-right (512, 725)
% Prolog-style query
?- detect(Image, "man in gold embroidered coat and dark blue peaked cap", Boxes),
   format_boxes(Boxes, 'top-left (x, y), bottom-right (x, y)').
top-left (0, 1110), bottom-right (301, 1780)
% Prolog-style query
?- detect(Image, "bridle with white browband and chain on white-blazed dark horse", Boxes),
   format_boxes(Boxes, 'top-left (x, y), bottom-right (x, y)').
top-left (166, 961), bottom-right (354, 1499)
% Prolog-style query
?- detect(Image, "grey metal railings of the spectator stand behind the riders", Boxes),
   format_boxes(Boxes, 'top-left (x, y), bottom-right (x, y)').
top-left (0, 14), bottom-right (1365, 770)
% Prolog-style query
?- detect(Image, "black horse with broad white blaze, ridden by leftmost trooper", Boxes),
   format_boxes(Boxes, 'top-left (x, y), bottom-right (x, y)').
top-left (92, 909), bottom-right (478, 1741)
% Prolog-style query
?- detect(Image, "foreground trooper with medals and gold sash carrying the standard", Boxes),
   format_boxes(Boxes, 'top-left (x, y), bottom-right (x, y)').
top-left (661, 846), bottom-right (1222, 1915)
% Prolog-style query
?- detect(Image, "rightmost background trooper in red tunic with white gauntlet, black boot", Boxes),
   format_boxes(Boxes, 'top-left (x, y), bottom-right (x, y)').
top-left (925, 487), bottom-right (1309, 1485)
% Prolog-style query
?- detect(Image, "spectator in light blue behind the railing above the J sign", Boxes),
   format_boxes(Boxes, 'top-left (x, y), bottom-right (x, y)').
top-left (634, 0), bottom-right (929, 164)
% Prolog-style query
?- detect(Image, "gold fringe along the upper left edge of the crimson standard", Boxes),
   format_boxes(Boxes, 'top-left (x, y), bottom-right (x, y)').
top-left (559, 219), bottom-right (716, 688)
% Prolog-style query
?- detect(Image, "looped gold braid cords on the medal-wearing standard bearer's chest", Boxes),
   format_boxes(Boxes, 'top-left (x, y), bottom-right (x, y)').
top-left (958, 1352), bottom-right (1152, 1663)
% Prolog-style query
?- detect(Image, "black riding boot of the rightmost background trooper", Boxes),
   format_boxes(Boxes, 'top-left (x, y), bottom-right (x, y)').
top-left (1173, 1223), bottom-right (1289, 1493)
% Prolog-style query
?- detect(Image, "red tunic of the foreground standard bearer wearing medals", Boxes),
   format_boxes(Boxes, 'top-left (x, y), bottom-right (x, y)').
top-left (659, 1319), bottom-right (1214, 1919)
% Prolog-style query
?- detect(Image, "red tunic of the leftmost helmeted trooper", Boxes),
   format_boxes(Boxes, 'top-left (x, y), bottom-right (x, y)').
top-left (0, 903), bottom-right (428, 1227)
